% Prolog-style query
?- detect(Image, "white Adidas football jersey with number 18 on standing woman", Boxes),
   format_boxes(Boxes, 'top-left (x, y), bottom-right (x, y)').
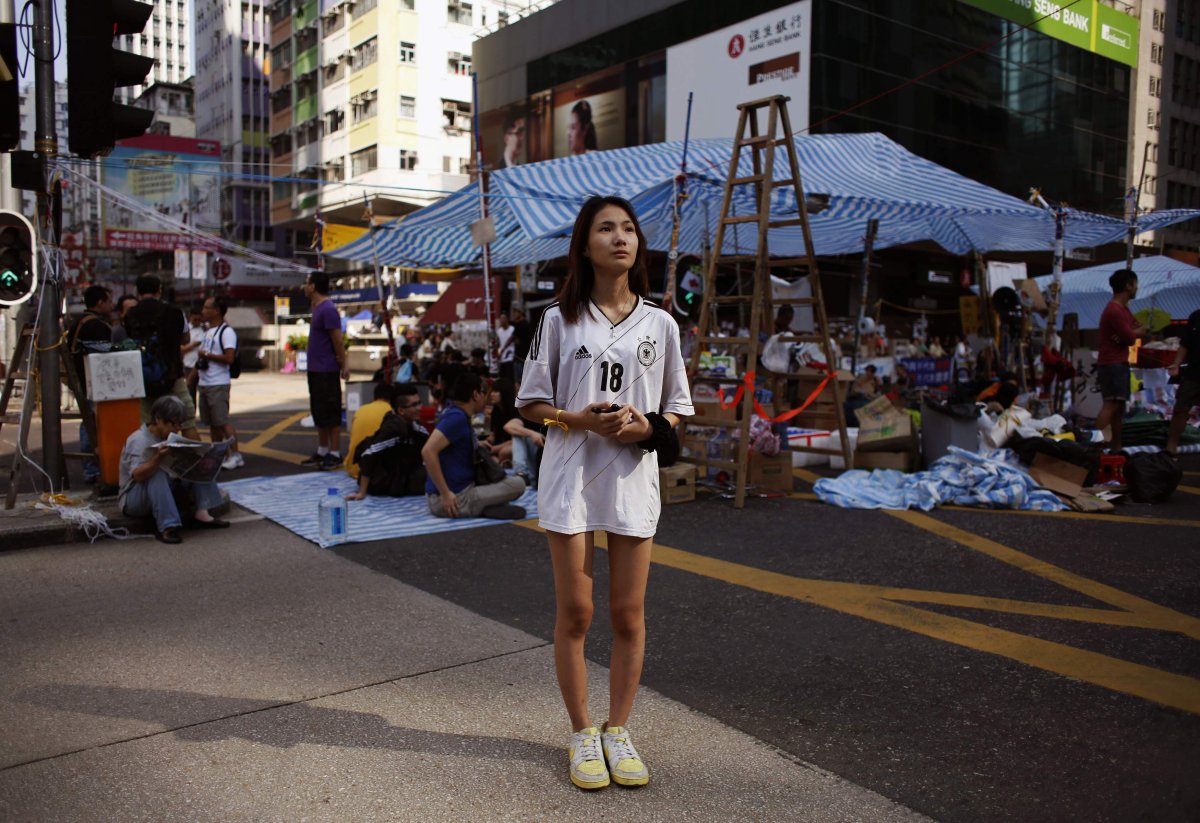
top-left (517, 298), bottom-right (695, 537)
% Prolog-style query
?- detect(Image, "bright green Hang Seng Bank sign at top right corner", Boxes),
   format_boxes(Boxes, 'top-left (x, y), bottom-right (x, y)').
top-left (962, 0), bottom-right (1139, 67)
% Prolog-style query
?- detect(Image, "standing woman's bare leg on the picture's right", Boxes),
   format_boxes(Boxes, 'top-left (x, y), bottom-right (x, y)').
top-left (608, 534), bottom-right (653, 726)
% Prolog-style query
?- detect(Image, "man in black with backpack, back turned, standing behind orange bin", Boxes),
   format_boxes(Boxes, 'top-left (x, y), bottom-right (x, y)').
top-left (125, 275), bottom-right (199, 440)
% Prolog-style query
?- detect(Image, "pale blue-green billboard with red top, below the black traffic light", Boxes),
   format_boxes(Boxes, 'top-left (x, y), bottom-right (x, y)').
top-left (101, 134), bottom-right (221, 252)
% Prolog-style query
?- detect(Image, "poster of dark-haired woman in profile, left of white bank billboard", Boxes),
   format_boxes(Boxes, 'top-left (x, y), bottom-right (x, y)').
top-left (554, 67), bottom-right (625, 157)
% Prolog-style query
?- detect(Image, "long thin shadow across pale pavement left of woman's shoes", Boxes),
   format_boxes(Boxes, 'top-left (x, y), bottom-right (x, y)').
top-left (13, 684), bottom-right (563, 768)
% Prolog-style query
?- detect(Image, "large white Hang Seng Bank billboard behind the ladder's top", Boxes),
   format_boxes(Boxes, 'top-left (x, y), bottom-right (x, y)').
top-left (667, 0), bottom-right (812, 140)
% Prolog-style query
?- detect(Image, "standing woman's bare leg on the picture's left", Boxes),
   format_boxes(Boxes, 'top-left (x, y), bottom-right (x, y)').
top-left (546, 531), bottom-right (595, 732)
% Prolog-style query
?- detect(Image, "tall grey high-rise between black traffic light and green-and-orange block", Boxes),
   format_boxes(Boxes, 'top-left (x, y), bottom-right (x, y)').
top-left (194, 0), bottom-right (276, 252)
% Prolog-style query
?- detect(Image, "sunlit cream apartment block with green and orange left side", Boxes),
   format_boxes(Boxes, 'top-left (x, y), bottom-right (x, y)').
top-left (270, 0), bottom-right (546, 266)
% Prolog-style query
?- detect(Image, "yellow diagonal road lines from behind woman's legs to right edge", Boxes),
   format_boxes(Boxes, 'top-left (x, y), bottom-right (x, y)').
top-left (517, 512), bottom-right (1200, 714)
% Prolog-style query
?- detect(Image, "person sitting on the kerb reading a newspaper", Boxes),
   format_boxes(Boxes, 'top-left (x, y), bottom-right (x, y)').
top-left (120, 395), bottom-right (229, 543)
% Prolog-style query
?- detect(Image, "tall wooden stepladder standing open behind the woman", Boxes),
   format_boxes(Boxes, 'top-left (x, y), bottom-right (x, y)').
top-left (682, 95), bottom-right (852, 509)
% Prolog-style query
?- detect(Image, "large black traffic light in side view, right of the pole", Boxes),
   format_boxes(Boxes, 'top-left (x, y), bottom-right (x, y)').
top-left (67, 0), bottom-right (154, 157)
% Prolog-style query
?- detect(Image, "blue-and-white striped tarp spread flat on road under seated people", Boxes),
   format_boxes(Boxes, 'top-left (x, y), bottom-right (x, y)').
top-left (221, 471), bottom-right (538, 545)
